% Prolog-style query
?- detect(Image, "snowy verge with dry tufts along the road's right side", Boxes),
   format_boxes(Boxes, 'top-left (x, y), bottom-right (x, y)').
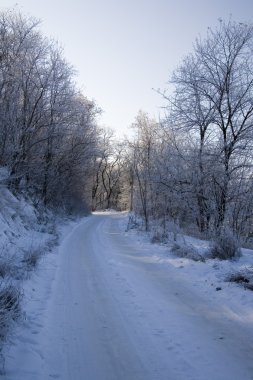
top-left (121, 221), bottom-right (253, 328)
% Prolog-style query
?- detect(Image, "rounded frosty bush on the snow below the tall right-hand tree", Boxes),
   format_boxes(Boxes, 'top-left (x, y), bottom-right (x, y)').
top-left (210, 230), bottom-right (241, 260)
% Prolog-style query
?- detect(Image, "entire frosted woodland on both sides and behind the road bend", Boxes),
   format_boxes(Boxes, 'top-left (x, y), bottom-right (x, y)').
top-left (0, 11), bottom-right (253, 241)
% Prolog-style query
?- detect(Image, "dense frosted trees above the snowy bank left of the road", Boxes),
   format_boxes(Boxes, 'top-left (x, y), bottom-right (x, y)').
top-left (0, 11), bottom-right (99, 209)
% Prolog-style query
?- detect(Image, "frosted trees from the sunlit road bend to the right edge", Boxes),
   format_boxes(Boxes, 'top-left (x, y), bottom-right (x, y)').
top-left (93, 19), bottom-right (253, 258)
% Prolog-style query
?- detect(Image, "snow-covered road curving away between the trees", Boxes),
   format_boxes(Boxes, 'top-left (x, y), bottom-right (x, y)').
top-left (6, 213), bottom-right (253, 380)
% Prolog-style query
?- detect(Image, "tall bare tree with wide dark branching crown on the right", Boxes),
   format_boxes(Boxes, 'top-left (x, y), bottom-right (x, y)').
top-left (164, 20), bottom-right (253, 230)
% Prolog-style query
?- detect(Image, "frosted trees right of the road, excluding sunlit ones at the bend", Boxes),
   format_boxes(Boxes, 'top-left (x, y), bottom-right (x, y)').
top-left (128, 20), bottom-right (253, 240)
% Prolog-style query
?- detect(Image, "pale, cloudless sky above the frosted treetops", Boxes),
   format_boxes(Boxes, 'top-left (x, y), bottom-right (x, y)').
top-left (0, 0), bottom-right (253, 135)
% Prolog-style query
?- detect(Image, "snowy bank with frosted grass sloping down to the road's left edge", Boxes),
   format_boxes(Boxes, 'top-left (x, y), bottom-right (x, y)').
top-left (0, 168), bottom-right (66, 373)
